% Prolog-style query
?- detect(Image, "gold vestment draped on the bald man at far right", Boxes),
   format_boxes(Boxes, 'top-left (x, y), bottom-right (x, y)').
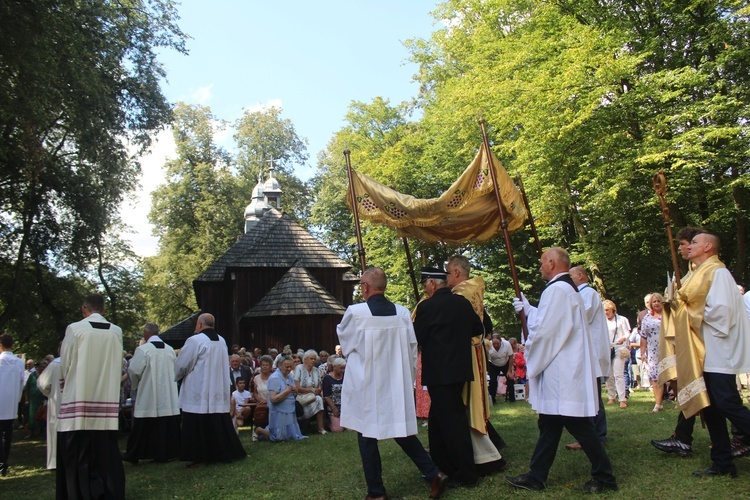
top-left (672, 255), bottom-right (725, 418)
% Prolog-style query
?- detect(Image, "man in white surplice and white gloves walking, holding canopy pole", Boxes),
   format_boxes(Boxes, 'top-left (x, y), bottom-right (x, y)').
top-left (505, 248), bottom-right (617, 493)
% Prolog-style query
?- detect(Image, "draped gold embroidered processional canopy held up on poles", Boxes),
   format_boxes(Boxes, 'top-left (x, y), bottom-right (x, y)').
top-left (346, 147), bottom-right (526, 245)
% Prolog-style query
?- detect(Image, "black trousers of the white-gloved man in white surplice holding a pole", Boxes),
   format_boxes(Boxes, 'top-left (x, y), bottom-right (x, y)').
top-left (529, 414), bottom-right (617, 486)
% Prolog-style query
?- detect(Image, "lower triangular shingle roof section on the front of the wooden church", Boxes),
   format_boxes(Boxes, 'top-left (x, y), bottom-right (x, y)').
top-left (244, 266), bottom-right (346, 318)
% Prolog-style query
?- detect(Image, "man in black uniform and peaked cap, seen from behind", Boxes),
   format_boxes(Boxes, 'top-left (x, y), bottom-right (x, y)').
top-left (414, 267), bottom-right (484, 485)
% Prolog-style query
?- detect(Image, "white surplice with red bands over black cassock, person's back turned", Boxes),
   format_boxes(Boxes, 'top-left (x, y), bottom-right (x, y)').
top-left (57, 313), bottom-right (125, 499)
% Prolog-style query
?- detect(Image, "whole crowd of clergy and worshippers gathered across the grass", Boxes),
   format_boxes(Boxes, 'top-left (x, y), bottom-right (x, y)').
top-left (0, 228), bottom-right (750, 499)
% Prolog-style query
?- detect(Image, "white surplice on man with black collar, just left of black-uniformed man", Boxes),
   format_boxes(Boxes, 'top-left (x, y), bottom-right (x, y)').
top-left (336, 304), bottom-right (417, 439)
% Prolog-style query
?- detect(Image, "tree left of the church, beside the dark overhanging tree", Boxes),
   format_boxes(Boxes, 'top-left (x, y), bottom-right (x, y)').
top-left (145, 103), bottom-right (242, 325)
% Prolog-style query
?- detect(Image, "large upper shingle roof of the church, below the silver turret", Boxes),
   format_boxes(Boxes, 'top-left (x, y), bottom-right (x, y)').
top-left (195, 209), bottom-right (351, 282)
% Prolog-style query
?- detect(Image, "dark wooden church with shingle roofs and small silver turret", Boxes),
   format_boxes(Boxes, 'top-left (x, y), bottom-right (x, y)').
top-left (162, 170), bottom-right (359, 352)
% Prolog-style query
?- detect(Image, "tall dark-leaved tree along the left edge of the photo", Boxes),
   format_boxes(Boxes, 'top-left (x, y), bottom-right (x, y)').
top-left (0, 0), bottom-right (184, 352)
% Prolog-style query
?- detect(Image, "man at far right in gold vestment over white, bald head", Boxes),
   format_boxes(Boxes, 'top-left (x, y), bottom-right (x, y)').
top-left (674, 232), bottom-right (750, 476)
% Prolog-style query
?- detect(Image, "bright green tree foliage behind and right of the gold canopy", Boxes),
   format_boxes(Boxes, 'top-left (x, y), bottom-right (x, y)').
top-left (313, 0), bottom-right (750, 331)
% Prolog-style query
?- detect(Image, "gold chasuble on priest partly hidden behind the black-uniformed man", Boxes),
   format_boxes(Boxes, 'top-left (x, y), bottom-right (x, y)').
top-left (452, 276), bottom-right (490, 434)
